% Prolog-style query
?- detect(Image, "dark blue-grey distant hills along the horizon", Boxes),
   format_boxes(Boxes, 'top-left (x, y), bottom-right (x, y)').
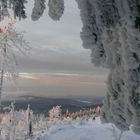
top-left (2, 96), bottom-right (103, 114)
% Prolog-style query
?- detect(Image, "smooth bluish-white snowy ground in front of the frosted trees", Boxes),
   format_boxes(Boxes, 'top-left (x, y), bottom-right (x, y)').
top-left (36, 118), bottom-right (140, 140)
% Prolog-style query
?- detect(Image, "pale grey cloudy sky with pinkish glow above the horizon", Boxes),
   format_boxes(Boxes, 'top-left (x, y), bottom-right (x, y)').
top-left (4, 0), bottom-right (108, 97)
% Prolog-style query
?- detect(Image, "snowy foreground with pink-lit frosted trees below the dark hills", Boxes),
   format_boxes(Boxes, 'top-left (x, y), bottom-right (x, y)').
top-left (0, 103), bottom-right (140, 140)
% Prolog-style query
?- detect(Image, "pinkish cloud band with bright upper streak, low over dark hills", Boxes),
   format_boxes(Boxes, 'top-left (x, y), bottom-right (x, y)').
top-left (5, 73), bottom-right (106, 97)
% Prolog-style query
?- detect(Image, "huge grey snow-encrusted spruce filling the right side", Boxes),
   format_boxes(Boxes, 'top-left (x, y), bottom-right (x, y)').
top-left (76, 0), bottom-right (140, 134)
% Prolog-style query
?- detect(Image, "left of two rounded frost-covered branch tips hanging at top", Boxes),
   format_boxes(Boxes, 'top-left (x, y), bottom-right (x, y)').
top-left (31, 0), bottom-right (45, 21)
